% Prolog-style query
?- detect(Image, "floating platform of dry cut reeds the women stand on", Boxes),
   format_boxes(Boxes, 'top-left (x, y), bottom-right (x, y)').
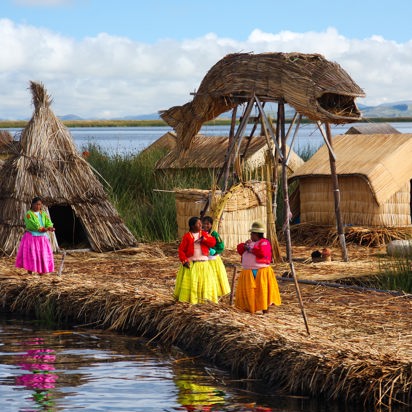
top-left (0, 244), bottom-right (412, 411)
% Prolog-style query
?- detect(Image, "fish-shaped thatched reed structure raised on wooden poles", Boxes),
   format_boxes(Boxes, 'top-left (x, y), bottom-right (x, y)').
top-left (161, 53), bottom-right (365, 149)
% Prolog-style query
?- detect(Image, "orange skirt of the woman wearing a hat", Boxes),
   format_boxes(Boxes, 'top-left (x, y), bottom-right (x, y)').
top-left (235, 266), bottom-right (282, 313)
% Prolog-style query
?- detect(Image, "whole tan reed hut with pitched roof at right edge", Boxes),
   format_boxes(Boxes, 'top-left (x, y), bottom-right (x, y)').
top-left (289, 134), bottom-right (412, 227)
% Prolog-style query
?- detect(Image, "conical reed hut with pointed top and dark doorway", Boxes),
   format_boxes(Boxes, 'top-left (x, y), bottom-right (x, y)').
top-left (0, 82), bottom-right (136, 255)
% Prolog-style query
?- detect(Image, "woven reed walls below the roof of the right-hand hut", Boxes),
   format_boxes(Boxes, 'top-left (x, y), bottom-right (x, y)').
top-left (299, 176), bottom-right (411, 227)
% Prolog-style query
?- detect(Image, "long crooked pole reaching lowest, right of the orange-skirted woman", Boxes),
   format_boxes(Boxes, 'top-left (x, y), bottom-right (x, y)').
top-left (277, 101), bottom-right (310, 335)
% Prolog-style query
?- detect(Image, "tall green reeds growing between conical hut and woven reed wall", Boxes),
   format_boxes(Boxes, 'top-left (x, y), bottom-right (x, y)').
top-left (87, 145), bottom-right (214, 242)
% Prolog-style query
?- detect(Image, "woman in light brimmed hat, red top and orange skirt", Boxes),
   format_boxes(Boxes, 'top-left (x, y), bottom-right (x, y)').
top-left (235, 222), bottom-right (281, 313)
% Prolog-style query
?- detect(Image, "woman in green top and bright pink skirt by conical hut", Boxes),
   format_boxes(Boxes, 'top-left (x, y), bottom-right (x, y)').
top-left (16, 197), bottom-right (55, 275)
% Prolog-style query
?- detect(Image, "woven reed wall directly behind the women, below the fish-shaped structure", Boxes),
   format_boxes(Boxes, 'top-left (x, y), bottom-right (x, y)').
top-left (176, 182), bottom-right (267, 249)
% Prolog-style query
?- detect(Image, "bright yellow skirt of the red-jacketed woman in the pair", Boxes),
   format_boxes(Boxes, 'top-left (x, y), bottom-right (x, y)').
top-left (173, 260), bottom-right (218, 304)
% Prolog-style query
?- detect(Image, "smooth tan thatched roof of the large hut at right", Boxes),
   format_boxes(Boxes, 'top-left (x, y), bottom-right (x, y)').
top-left (290, 133), bottom-right (412, 205)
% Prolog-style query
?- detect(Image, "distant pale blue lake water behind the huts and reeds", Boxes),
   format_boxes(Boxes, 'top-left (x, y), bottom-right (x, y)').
top-left (9, 122), bottom-right (412, 155)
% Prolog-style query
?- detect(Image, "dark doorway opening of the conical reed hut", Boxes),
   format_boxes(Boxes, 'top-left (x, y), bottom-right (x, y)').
top-left (49, 205), bottom-right (90, 249)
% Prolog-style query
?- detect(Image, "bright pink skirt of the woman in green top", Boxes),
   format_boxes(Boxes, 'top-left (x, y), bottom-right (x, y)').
top-left (16, 232), bottom-right (54, 273)
